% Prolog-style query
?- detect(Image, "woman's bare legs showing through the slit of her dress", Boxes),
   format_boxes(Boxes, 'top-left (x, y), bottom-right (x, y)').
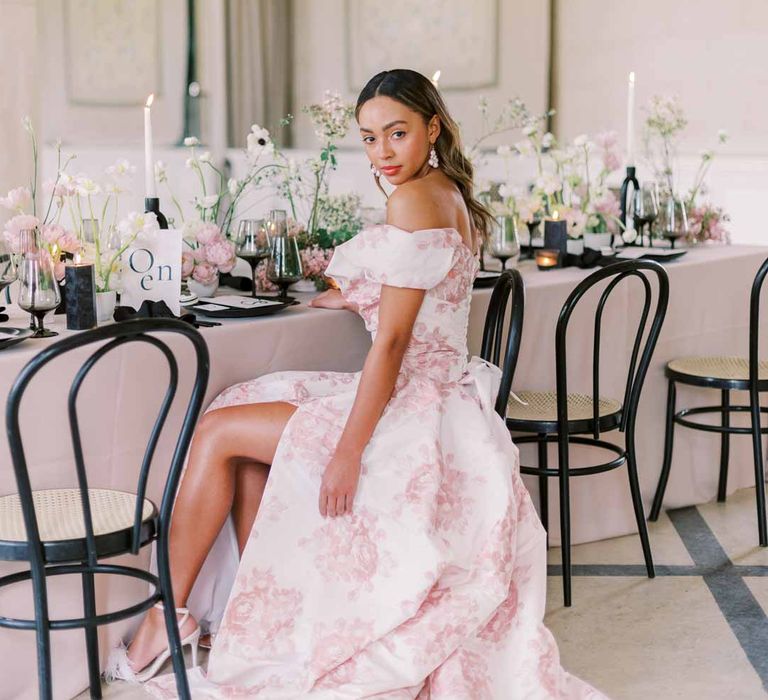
top-left (128, 401), bottom-right (296, 671)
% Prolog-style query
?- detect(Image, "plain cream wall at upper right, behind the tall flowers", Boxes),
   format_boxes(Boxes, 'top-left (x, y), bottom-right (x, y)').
top-left (556, 0), bottom-right (768, 244)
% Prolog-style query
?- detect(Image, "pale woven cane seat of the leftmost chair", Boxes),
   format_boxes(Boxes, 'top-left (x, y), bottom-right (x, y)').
top-left (0, 489), bottom-right (157, 560)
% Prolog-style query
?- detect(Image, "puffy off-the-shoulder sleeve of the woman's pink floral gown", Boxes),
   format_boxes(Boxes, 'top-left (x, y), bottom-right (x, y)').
top-left (325, 225), bottom-right (456, 293)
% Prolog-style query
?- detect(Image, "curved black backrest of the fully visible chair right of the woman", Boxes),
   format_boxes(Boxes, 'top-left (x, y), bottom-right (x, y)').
top-left (555, 260), bottom-right (669, 440)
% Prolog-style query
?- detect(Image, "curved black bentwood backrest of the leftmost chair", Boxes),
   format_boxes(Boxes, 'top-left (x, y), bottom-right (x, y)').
top-left (5, 319), bottom-right (209, 566)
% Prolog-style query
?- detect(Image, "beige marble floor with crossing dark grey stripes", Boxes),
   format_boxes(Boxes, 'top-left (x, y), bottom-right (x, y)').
top-left (73, 489), bottom-right (768, 700)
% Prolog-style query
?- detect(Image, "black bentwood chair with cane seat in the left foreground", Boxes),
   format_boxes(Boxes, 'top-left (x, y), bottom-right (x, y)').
top-left (0, 319), bottom-right (209, 700)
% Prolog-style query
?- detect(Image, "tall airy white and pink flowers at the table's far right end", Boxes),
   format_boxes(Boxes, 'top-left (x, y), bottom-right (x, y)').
top-left (643, 95), bottom-right (730, 243)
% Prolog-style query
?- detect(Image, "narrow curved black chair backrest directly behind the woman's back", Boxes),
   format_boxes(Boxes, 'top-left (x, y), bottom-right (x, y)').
top-left (480, 270), bottom-right (525, 418)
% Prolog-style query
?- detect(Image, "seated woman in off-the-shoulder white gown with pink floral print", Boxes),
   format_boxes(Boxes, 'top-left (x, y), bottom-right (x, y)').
top-left (114, 70), bottom-right (601, 700)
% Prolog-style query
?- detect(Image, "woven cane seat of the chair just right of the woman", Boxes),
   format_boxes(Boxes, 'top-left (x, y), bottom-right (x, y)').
top-left (507, 391), bottom-right (621, 430)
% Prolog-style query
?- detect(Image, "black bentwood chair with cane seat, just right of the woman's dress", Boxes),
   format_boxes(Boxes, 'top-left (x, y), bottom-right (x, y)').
top-left (507, 260), bottom-right (669, 606)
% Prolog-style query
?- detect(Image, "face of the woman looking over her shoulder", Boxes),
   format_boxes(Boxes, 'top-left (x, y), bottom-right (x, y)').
top-left (358, 95), bottom-right (440, 185)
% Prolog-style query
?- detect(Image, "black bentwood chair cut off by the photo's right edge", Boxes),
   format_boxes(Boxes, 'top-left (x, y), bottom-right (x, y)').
top-left (649, 260), bottom-right (768, 547)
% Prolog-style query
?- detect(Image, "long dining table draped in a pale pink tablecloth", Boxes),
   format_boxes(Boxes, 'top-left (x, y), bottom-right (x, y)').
top-left (0, 246), bottom-right (768, 700)
